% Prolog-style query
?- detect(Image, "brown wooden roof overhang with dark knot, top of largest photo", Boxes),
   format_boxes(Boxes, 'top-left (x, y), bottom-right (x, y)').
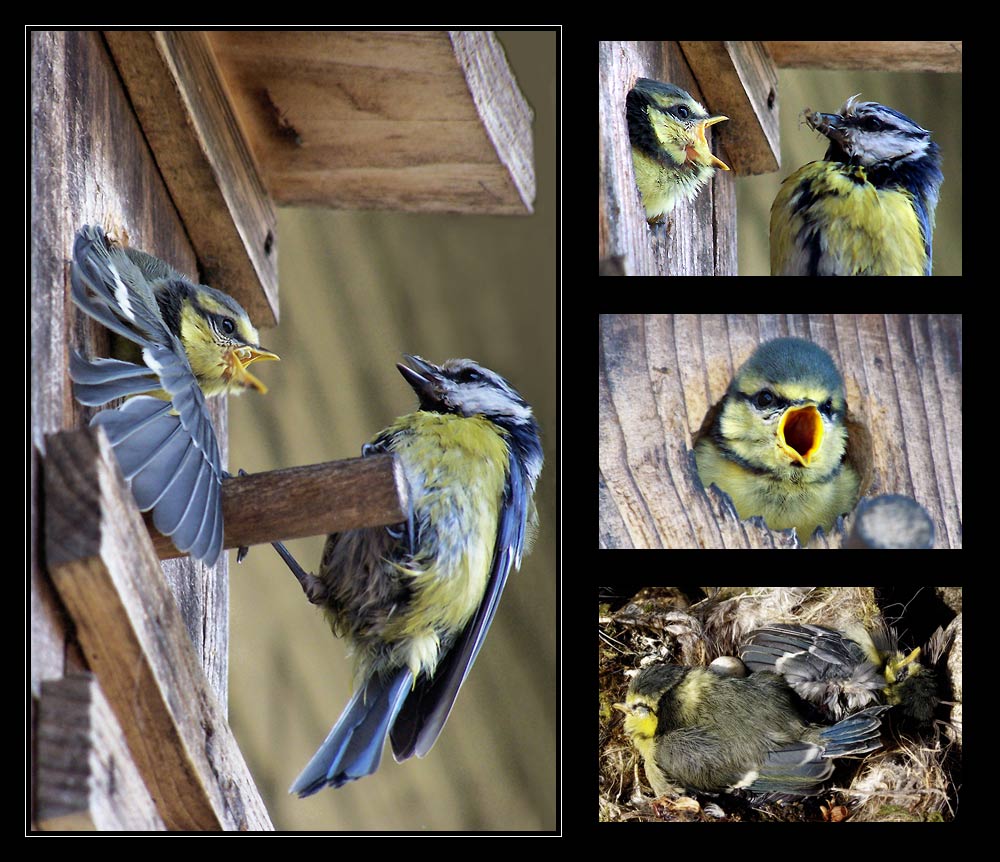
top-left (208, 30), bottom-right (534, 214)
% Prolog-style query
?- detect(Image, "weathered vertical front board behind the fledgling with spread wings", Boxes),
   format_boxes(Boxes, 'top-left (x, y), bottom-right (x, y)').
top-left (29, 31), bottom-right (229, 768)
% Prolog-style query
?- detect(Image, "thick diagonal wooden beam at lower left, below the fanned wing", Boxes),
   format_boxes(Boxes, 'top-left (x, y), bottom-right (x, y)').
top-left (45, 428), bottom-right (272, 830)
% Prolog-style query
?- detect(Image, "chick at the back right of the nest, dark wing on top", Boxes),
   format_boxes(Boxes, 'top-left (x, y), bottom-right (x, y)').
top-left (740, 621), bottom-right (946, 724)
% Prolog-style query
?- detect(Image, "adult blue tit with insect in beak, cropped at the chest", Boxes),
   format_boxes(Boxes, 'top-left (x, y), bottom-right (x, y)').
top-left (771, 96), bottom-right (944, 275)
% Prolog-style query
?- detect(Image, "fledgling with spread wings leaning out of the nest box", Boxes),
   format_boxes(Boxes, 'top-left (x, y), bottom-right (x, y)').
top-left (70, 226), bottom-right (278, 565)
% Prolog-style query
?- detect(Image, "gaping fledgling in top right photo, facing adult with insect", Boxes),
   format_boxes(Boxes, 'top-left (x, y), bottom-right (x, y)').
top-left (625, 78), bottom-right (729, 224)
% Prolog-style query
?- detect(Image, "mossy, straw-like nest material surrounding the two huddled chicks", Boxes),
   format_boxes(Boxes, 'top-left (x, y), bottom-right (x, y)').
top-left (598, 587), bottom-right (961, 822)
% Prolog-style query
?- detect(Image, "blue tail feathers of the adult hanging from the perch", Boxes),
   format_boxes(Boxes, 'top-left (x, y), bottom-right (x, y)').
top-left (288, 668), bottom-right (413, 797)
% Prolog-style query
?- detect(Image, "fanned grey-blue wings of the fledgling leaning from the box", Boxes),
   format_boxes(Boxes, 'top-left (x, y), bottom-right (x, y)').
top-left (70, 226), bottom-right (223, 565)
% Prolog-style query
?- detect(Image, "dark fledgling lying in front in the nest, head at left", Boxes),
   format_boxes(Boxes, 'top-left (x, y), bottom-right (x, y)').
top-left (614, 664), bottom-right (888, 796)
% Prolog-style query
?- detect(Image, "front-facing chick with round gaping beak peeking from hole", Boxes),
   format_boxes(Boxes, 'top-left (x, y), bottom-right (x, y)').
top-left (695, 338), bottom-right (860, 542)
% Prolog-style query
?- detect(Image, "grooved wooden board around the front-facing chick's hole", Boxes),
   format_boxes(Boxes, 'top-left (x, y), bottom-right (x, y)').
top-left (598, 315), bottom-right (962, 548)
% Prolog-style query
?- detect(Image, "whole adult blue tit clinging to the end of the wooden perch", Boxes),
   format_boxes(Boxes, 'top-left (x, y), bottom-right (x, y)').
top-left (275, 355), bottom-right (542, 796)
